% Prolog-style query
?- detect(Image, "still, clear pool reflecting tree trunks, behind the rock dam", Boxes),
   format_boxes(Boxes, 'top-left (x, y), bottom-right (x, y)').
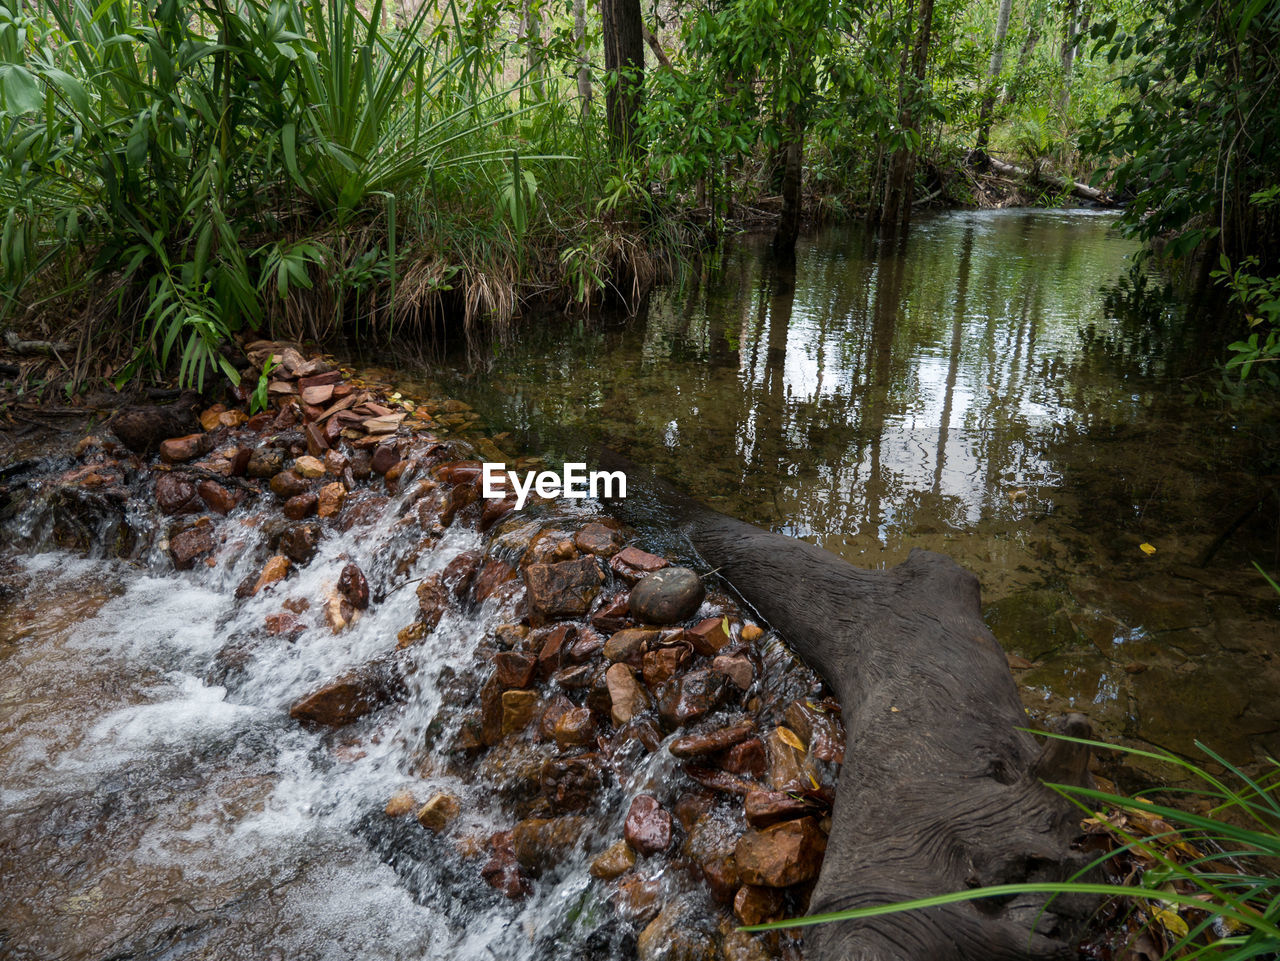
top-left (427, 210), bottom-right (1280, 761)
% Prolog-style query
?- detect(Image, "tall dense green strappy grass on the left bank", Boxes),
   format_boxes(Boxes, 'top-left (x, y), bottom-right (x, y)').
top-left (0, 0), bottom-right (691, 385)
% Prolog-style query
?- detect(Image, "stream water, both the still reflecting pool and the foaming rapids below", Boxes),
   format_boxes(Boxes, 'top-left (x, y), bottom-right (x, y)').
top-left (0, 211), bottom-right (1280, 961)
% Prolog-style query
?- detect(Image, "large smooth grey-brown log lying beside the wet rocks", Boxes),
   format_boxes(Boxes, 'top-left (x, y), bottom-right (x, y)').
top-left (602, 454), bottom-right (1092, 961)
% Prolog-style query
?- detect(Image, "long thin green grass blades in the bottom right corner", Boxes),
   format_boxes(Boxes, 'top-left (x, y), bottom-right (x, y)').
top-left (745, 737), bottom-right (1280, 961)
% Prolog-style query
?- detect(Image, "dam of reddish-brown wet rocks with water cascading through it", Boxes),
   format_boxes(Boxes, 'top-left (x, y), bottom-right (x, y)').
top-left (0, 343), bottom-right (844, 961)
